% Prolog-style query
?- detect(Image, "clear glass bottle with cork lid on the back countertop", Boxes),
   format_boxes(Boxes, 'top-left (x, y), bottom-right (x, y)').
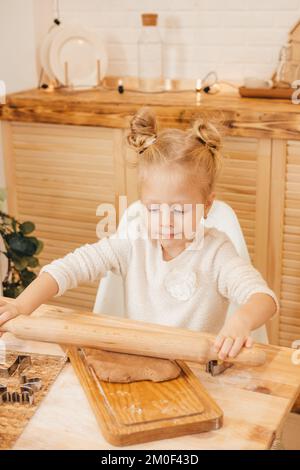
top-left (138, 13), bottom-right (163, 92)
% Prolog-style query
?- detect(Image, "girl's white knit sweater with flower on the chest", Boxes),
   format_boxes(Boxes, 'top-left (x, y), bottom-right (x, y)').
top-left (40, 214), bottom-right (279, 333)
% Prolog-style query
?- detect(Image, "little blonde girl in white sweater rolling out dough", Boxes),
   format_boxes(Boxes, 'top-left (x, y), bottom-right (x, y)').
top-left (0, 108), bottom-right (279, 359)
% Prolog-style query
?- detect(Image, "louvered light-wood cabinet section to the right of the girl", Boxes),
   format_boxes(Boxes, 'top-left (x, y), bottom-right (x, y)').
top-left (213, 137), bottom-right (300, 347)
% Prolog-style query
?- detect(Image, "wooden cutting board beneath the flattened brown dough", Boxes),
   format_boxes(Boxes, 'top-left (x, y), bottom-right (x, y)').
top-left (67, 347), bottom-right (223, 446)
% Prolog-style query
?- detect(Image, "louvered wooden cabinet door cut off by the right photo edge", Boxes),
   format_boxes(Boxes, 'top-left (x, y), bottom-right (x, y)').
top-left (270, 140), bottom-right (300, 347)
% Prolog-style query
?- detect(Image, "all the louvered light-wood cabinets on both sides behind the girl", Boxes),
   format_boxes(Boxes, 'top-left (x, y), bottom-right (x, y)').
top-left (0, 108), bottom-right (300, 347)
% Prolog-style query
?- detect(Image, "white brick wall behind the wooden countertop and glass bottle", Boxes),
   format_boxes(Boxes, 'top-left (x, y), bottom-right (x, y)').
top-left (54, 0), bottom-right (300, 81)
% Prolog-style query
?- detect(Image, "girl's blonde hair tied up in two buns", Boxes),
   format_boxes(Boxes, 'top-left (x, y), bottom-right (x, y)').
top-left (127, 107), bottom-right (222, 197)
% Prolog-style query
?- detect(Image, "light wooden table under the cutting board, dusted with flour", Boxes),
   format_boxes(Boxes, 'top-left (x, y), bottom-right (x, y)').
top-left (3, 310), bottom-right (300, 450)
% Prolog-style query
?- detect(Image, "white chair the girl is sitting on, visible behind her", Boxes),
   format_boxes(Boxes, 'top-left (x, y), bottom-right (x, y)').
top-left (93, 200), bottom-right (268, 343)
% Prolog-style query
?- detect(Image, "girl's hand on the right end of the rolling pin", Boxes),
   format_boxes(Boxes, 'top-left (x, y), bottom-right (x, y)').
top-left (214, 311), bottom-right (253, 360)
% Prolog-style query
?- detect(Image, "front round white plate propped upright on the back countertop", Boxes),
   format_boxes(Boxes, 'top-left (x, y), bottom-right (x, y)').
top-left (49, 25), bottom-right (107, 86)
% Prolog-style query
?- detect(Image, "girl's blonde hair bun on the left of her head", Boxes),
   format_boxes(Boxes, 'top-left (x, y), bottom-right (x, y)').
top-left (127, 107), bottom-right (157, 153)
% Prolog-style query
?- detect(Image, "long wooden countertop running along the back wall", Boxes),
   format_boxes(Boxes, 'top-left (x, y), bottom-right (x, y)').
top-left (0, 88), bottom-right (300, 139)
